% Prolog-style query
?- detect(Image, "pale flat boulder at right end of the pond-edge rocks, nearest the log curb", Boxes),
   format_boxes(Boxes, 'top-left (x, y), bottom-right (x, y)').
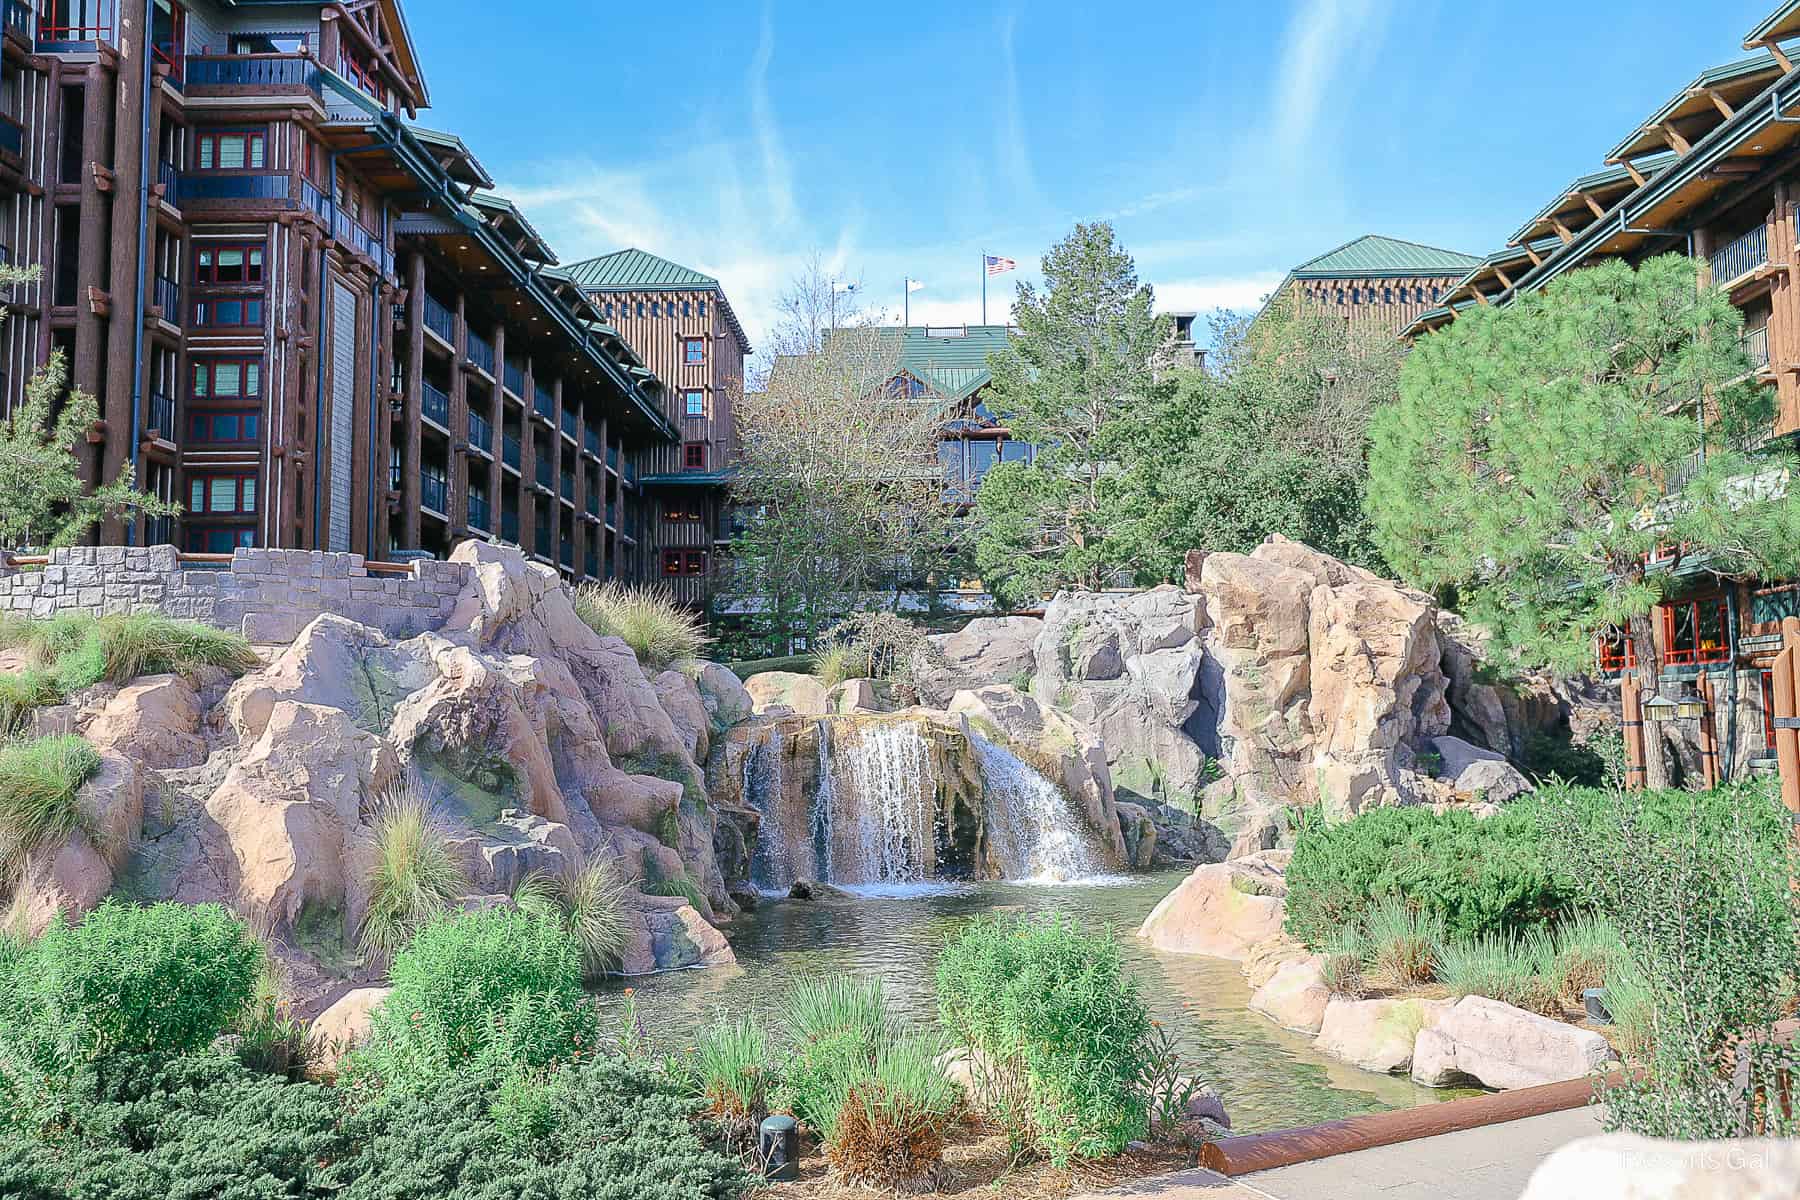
top-left (1413, 997), bottom-right (1613, 1090)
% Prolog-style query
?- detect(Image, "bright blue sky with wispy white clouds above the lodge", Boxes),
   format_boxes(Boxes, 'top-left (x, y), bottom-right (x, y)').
top-left (407, 0), bottom-right (1773, 347)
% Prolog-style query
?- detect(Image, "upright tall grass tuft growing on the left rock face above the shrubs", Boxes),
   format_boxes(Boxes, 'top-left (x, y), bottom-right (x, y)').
top-left (356, 786), bottom-right (468, 963)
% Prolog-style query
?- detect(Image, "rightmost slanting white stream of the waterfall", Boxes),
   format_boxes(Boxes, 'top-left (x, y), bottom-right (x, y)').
top-left (974, 734), bottom-right (1105, 883)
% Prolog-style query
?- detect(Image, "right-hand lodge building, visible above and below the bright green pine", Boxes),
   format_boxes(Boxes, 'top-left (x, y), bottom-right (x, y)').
top-left (1404, 0), bottom-right (1800, 779)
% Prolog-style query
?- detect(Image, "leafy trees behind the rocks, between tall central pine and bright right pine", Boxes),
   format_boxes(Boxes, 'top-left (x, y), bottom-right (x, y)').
top-left (1130, 293), bottom-right (1404, 579)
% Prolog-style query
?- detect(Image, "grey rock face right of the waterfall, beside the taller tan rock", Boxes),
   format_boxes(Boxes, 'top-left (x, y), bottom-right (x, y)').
top-left (1031, 587), bottom-right (1215, 797)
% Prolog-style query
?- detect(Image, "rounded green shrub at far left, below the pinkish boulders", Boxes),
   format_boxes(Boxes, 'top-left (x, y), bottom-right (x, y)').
top-left (22, 900), bottom-right (263, 1060)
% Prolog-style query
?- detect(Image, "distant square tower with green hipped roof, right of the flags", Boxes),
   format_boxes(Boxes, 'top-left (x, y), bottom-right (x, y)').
top-left (1256, 234), bottom-right (1480, 331)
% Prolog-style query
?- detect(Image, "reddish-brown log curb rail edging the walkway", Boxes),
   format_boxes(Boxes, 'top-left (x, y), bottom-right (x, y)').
top-left (1201, 1079), bottom-right (1593, 1175)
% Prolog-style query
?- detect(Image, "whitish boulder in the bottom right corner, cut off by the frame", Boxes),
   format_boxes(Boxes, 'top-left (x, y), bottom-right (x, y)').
top-left (1519, 1133), bottom-right (1800, 1200)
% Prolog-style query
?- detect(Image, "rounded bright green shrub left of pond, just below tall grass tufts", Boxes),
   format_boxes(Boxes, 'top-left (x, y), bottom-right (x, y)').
top-left (358, 909), bottom-right (599, 1087)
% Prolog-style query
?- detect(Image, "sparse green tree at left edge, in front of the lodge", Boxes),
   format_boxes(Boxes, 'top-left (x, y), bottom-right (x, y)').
top-left (0, 347), bottom-right (180, 549)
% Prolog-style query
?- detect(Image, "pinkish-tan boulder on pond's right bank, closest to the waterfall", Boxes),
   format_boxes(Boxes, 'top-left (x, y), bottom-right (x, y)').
top-left (1138, 855), bottom-right (1287, 959)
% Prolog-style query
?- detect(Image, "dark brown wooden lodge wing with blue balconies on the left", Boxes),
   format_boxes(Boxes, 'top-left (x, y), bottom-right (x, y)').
top-left (0, 0), bottom-right (698, 579)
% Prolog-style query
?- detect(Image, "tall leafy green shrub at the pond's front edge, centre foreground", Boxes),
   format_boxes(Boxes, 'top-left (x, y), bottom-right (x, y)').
top-left (938, 916), bottom-right (1150, 1164)
